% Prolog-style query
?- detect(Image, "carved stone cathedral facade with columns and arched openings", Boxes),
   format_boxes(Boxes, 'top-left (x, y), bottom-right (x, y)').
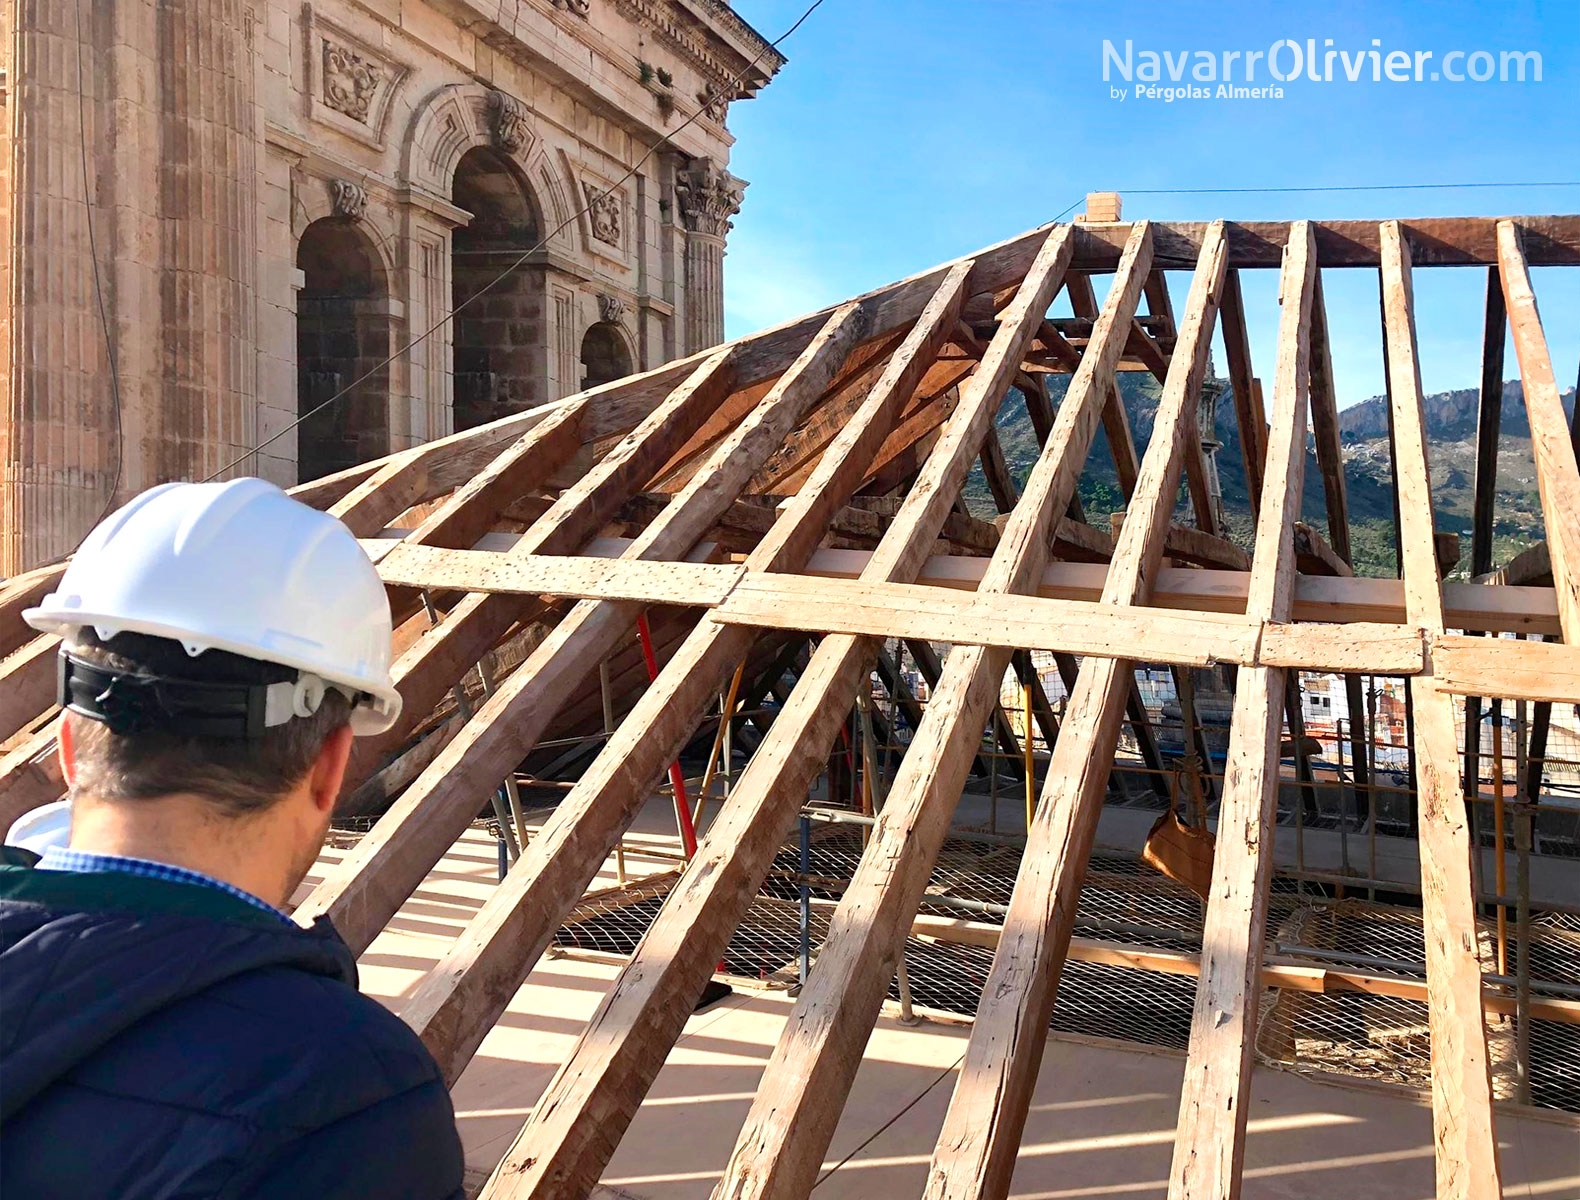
top-left (0, 0), bottom-right (784, 574)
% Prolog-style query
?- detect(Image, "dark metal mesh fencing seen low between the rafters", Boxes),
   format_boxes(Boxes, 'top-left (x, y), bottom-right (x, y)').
top-left (556, 821), bottom-right (1580, 1111)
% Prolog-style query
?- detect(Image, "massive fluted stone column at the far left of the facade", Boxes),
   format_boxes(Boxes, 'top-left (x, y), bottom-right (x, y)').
top-left (0, 0), bottom-right (256, 574)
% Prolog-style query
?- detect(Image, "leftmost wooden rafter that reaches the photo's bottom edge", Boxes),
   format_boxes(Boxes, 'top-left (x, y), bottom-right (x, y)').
top-left (485, 228), bottom-right (1070, 1200)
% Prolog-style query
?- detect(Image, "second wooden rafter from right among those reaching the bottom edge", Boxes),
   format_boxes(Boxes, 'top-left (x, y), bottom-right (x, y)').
top-left (1169, 223), bottom-right (1318, 1200)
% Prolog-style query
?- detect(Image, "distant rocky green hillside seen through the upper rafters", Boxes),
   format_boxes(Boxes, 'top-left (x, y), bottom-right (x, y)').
top-left (969, 373), bottom-right (1575, 575)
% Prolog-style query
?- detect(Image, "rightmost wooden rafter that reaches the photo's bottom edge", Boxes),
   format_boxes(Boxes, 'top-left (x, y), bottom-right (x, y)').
top-left (1381, 221), bottom-right (1497, 1200)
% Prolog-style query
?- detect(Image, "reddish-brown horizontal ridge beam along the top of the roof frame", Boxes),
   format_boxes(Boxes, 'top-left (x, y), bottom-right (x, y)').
top-left (1071, 215), bottom-right (1580, 270)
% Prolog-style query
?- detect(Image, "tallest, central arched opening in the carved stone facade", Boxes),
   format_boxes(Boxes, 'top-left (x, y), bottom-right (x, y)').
top-left (450, 145), bottom-right (548, 428)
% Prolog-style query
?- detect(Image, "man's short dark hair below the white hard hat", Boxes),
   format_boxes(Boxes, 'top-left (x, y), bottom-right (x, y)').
top-left (66, 629), bottom-right (351, 817)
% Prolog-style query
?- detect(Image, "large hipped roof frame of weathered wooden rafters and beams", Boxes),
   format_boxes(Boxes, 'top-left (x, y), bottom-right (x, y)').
top-left (0, 217), bottom-right (1580, 1200)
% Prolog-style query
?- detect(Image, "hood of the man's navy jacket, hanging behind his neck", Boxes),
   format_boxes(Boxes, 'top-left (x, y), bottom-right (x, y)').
top-left (0, 855), bottom-right (357, 1121)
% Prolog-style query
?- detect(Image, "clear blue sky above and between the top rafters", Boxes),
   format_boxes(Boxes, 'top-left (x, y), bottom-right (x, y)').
top-left (725, 0), bottom-right (1580, 406)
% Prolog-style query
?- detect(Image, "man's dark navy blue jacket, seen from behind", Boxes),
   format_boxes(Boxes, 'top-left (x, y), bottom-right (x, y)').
top-left (0, 855), bottom-right (463, 1200)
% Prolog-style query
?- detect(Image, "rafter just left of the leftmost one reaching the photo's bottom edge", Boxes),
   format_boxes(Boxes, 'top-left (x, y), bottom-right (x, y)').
top-left (403, 262), bottom-right (973, 1111)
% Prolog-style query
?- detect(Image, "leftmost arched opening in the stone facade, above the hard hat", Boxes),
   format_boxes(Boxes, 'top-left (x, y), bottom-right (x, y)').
top-left (297, 217), bottom-right (390, 479)
